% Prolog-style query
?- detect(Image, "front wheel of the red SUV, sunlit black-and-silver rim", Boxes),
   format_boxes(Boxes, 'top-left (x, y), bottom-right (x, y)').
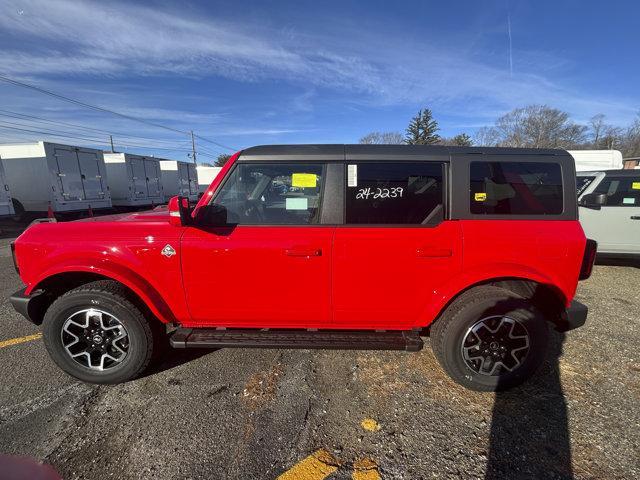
top-left (43, 280), bottom-right (159, 384)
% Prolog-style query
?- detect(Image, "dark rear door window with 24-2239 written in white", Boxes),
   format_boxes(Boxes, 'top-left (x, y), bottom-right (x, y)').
top-left (346, 161), bottom-right (443, 225)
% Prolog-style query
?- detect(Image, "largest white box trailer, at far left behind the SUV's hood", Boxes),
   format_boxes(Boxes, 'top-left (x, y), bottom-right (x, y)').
top-left (0, 142), bottom-right (111, 214)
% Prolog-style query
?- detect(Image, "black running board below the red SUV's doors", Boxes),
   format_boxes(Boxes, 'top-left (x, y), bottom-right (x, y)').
top-left (170, 328), bottom-right (423, 352)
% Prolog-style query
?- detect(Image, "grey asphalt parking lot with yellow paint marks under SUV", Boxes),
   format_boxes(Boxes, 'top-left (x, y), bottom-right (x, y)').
top-left (0, 240), bottom-right (640, 480)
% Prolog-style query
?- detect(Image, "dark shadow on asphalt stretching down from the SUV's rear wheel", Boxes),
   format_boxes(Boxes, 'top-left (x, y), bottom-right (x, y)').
top-left (485, 330), bottom-right (573, 480)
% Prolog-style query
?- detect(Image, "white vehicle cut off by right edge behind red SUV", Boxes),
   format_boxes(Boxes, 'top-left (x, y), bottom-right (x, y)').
top-left (576, 170), bottom-right (640, 261)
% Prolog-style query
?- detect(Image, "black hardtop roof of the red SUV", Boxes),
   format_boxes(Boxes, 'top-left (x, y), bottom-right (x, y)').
top-left (239, 144), bottom-right (569, 161)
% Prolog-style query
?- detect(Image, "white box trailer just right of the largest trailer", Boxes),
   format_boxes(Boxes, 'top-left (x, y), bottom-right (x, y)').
top-left (104, 152), bottom-right (164, 207)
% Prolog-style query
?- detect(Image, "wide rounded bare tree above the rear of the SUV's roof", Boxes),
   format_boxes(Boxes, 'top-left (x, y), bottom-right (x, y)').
top-left (479, 105), bottom-right (587, 148)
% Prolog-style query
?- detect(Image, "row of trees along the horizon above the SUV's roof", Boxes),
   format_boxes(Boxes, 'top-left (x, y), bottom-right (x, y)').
top-left (360, 105), bottom-right (640, 158)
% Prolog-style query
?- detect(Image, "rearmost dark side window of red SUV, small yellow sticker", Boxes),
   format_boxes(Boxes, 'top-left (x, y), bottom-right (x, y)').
top-left (469, 162), bottom-right (563, 215)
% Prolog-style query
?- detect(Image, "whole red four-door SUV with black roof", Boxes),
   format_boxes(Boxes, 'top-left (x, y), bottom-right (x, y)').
top-left (11, 145), bottom-right (596, 390)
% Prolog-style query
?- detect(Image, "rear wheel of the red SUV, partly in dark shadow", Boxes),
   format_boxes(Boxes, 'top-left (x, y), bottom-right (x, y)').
top-left (431, 286), bottom-right (549, 392)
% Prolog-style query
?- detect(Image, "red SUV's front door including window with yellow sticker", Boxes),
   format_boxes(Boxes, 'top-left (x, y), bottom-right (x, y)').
top-left (182, 162), bottom-right (335, 328)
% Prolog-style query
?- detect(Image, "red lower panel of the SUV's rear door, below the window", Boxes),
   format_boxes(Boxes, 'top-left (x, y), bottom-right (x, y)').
top-left (332, 221), bottom-right (462, 329)
